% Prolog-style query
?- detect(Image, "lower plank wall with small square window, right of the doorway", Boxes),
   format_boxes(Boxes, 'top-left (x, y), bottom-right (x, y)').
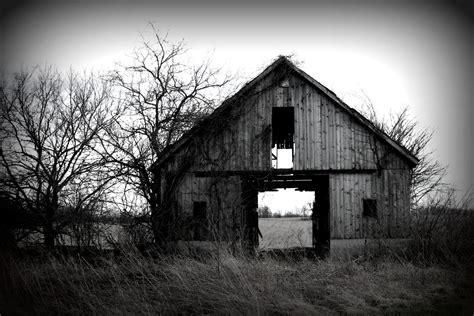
top-left (329, 164), bottom-right (410, 239)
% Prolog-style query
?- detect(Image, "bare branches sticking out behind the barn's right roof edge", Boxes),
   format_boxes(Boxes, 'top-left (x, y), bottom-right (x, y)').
top-left (362, 94), bottom-right (446, 205)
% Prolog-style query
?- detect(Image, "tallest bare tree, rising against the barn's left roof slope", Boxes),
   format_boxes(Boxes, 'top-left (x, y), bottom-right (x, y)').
top-left (103, 26), bottom-right (229, 241)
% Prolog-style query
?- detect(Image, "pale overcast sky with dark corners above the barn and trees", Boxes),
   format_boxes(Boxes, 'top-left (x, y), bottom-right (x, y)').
top-left (0, 0), bottom-right (474, 207)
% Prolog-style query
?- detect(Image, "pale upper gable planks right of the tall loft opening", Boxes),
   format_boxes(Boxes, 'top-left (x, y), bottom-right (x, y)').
top-left (290, 77), bottom-right (382, 170)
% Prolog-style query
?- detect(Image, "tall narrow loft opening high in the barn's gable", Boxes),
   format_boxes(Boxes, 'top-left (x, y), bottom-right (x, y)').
top-left (272, 106), bottom-right (295, 169)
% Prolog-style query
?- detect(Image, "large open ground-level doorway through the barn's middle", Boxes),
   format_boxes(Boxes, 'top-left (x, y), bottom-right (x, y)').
top-left (242, 171), bottom-right (330, 255)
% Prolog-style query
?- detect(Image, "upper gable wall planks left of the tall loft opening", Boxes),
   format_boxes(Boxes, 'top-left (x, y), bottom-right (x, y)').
top-left (165, 74), bottom-right (275, 172)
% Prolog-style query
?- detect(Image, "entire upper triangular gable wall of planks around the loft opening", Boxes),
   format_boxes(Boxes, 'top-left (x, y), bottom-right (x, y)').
top-left (163, 72), bottom-right (408, 175)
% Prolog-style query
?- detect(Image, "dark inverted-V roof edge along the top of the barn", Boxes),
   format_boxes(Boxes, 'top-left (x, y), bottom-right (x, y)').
top-left (150, 56), bottom-right (419, 169)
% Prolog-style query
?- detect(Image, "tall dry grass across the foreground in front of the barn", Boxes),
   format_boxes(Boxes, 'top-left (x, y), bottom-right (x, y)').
top-left (0, 248), bottom-right (474, 315)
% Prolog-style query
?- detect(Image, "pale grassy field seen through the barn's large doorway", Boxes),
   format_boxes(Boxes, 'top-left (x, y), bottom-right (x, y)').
top-left (258, 217), bottom-right (312, 249)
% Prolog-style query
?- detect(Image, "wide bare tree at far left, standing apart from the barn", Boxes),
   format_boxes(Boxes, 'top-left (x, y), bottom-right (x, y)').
top-left (0, 68), bottom-right (113, 246)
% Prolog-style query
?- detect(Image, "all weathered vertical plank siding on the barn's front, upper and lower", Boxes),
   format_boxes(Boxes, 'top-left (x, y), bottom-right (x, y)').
top-left (158, 71), bottom-right (410, 239)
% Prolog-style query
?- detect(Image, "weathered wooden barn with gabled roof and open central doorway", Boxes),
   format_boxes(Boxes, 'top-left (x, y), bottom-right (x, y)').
top-left (152, 57), bottom-right (418, 253)
